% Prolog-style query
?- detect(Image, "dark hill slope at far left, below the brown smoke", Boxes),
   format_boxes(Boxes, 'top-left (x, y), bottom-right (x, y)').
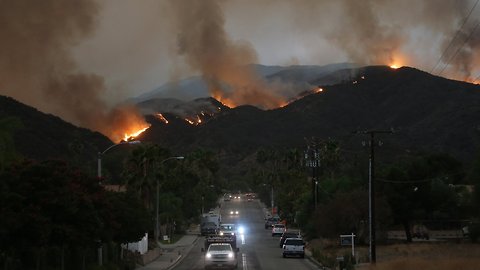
top-left (0, 96), bottom-right (112, 167)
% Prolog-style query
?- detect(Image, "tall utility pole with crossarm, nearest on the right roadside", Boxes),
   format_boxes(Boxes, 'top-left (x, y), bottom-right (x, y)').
top-left (355, 130), bottom-right (393, 264)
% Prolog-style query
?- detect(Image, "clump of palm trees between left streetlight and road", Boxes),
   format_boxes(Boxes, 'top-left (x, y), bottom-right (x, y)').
top-left (117, 143), bottom-right (223, 237)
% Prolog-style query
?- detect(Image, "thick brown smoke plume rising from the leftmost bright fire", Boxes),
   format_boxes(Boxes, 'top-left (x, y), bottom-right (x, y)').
top-left (0, 0), bottom-right (145, 141)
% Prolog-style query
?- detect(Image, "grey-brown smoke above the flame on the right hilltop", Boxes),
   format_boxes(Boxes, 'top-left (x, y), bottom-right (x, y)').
top-left (282, 0), bottom-right (480, 80)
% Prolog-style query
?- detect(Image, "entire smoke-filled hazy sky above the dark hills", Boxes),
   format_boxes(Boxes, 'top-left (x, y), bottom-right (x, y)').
top-left (0, 0), bottom-right (480, 138)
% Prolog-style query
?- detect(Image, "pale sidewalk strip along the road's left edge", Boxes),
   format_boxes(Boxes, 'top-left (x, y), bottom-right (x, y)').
top-left (136, 230), bottom-right (198, 270)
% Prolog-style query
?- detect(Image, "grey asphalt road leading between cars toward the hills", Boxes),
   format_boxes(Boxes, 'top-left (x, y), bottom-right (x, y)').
top-left (174, 198), bottom-right (318, 270)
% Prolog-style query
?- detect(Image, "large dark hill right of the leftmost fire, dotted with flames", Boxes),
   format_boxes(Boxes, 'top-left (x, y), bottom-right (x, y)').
top-left (135, 66), bottom-right (480, 173)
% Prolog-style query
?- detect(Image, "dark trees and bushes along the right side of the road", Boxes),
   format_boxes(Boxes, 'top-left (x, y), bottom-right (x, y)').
top-left (244, 141), bottom-right (480, 268)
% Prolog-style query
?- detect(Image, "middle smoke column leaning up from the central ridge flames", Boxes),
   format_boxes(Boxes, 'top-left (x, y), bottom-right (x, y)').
top-left (171, 0), bottom-right (285, 109)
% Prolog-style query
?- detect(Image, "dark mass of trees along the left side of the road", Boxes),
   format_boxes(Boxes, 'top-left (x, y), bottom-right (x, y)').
top-left (0, 144), bottom-right (223, 270)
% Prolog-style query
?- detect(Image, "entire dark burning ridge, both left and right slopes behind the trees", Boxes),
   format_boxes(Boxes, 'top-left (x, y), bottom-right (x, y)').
top-left (0, 66), bottom-right (480, 176)
